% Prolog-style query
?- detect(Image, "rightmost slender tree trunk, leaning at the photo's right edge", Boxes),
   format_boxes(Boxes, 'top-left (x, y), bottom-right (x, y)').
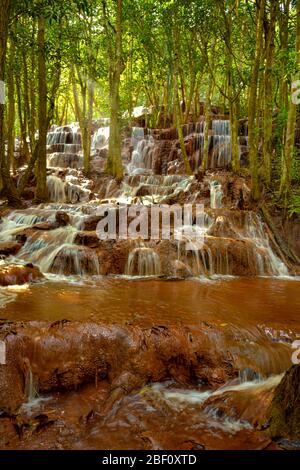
top-left (280, 0), bottom-right (300, 205)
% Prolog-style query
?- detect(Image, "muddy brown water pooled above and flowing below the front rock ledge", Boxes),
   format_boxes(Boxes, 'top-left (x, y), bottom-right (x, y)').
top-left (0, 278), bottom-right (300, 449)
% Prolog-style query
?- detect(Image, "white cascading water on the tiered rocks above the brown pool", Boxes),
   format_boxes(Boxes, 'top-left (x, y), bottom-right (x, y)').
top-left (0, 115), bottom-right (288, 276)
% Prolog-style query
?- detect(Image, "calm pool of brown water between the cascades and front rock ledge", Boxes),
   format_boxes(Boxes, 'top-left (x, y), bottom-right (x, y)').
top-left (0, 277), bottom-right (300, 331)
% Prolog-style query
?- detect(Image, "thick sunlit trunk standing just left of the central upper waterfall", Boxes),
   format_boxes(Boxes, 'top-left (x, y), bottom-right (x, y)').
top-left (106, 0), bottom-right (124, 180)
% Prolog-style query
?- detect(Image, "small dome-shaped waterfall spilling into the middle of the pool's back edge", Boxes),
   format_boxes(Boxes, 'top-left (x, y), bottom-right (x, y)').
top-left (125, 246), bottom-right (161, 276)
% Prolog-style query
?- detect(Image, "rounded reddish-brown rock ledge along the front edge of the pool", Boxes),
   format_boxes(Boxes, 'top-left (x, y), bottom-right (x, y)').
top-left (0, 321), bottom-right (237, 408)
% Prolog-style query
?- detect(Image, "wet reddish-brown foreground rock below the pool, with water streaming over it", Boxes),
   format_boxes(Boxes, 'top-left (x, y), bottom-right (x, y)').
top-left (0, 320), bottom-right (290, 450)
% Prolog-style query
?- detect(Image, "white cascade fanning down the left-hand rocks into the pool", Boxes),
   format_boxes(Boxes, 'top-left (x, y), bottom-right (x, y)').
top-left (0, 204), bottom-right (100, 276)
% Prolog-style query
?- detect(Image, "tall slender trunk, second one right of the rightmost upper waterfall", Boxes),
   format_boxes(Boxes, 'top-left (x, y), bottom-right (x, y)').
top-left (248, 0), bottom-right (266, 201)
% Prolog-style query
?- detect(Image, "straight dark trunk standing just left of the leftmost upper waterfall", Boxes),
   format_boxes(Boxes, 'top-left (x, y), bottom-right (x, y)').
top-left (35, 16), bottom-right (48, 202)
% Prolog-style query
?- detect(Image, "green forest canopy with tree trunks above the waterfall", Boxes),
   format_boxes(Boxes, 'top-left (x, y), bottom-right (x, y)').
top-left (0, 0), bottom-right (300, 213)
